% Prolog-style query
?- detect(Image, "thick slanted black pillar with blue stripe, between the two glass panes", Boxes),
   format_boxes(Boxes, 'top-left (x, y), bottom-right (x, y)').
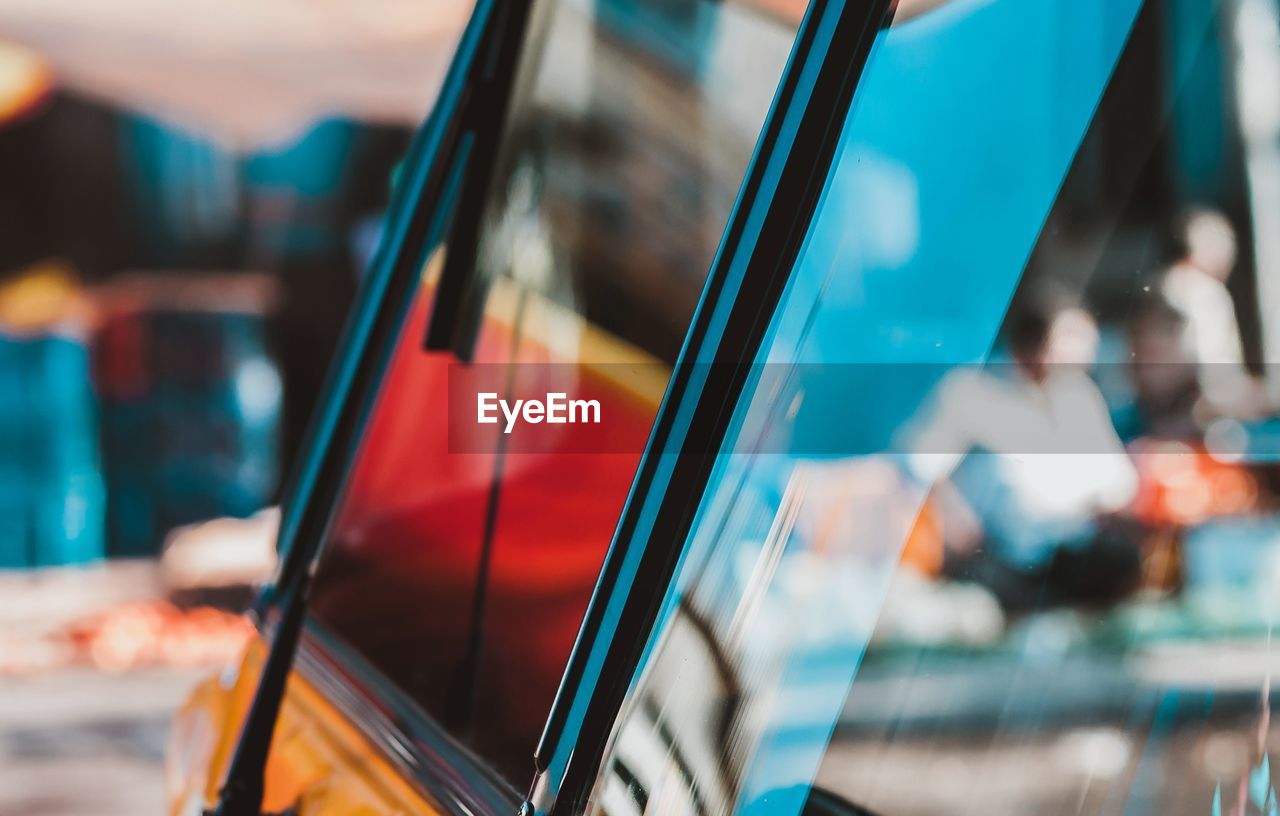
top-left (521, 0), bottom-right (897, 816)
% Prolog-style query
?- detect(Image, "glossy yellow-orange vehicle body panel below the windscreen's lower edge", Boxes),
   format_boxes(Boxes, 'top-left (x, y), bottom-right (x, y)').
top-left (165, 639), bottom-right (439, 816)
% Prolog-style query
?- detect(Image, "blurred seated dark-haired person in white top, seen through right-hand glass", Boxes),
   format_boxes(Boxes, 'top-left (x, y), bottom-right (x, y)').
top-left (906, 299), bottom-right (1140, 611)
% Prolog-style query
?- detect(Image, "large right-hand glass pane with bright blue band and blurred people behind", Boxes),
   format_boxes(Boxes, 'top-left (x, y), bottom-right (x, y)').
top-left (593, 0), bottom-right (1280, 816)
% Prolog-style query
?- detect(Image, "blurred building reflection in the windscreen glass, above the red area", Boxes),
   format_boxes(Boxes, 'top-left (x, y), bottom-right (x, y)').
top-left (499, 0), bottom-right (791, 361)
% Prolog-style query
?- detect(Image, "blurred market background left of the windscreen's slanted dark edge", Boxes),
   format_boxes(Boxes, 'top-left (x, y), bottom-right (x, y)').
top-left (0, 0), bottom-right (470, 816)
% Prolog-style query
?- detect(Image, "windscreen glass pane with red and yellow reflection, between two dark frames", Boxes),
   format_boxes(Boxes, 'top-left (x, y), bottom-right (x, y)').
top-left (302, 0), bottom-right (795, 785)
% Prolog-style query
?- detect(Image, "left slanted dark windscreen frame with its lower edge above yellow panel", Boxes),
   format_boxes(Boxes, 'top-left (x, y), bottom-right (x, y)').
top-left (218, 0), bottom-right (531, 816)
